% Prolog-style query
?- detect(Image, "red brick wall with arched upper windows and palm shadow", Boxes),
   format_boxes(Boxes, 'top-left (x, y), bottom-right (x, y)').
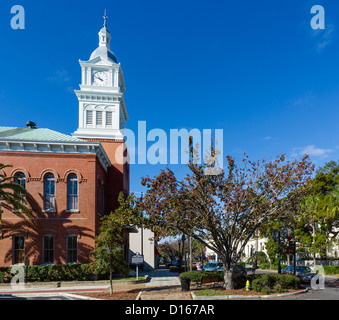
top-left (0, 152), bottom-right (103, 266)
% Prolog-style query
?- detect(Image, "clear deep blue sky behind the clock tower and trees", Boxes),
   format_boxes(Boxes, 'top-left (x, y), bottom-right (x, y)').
top-left (0, 0), bottom-right (339, 191)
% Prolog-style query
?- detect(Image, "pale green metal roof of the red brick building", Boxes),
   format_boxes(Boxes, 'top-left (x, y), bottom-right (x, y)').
top-left (0, 127), bottom-right (84, 142)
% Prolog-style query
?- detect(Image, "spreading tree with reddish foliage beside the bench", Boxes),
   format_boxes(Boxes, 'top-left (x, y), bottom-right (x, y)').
top-left (142, 154), bottom-right (314, 289)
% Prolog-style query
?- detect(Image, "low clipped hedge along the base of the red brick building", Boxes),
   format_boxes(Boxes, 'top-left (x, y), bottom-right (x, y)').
top-left (0, 264), bottom-right (106, 283)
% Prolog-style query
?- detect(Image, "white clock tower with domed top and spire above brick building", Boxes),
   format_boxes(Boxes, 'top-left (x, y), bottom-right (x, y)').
top-left (73, 14), bottom-right (128, 141)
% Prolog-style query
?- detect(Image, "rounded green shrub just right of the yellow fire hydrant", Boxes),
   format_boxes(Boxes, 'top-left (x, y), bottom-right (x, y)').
top-left (252, 274), bottom-right (300, 294)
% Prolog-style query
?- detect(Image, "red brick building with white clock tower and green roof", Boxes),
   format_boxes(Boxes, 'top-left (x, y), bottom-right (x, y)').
top-left (0, 18), bottom-right (133, 266)
